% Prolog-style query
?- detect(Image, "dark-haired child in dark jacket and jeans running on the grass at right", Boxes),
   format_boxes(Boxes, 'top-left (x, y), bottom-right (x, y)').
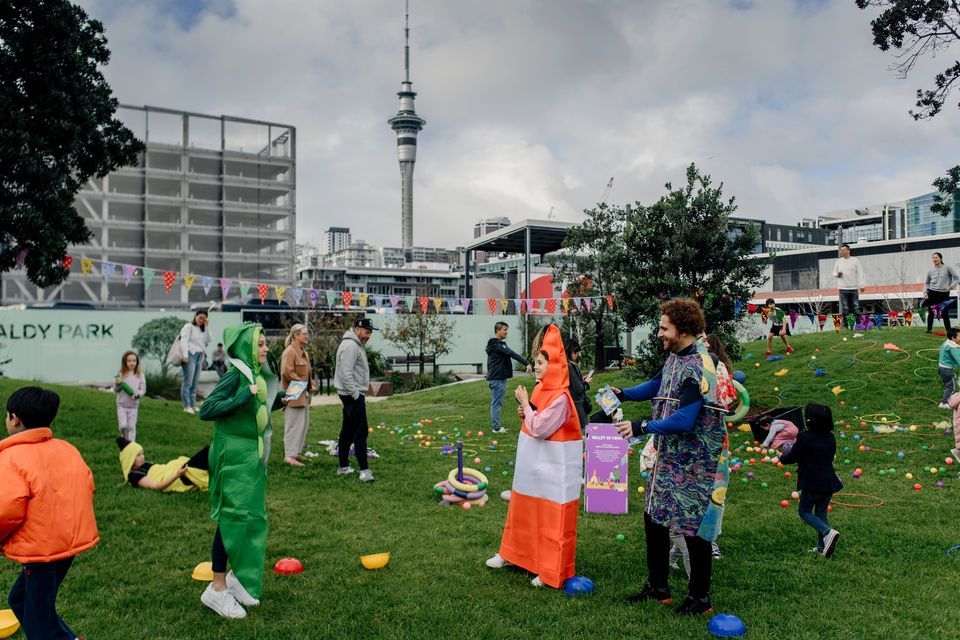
top-left (780, 404), bottom-right (843, 558)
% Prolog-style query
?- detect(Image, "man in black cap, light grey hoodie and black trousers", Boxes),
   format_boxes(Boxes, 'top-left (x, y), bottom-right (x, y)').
top-left (333, 318), bottom-right (377, 482)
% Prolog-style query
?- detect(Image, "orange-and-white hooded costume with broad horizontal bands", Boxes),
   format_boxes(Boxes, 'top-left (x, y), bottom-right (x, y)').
top-left (500, 325), bottom-right (583, 589)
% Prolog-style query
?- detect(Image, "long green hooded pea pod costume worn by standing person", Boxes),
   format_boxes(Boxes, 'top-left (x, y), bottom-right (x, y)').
top-left (200, 322), bottom-right (280, 598)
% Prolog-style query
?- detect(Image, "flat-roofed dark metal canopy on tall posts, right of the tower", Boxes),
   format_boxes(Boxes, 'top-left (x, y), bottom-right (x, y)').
top-left (464, 220), bottom-right (576, 298)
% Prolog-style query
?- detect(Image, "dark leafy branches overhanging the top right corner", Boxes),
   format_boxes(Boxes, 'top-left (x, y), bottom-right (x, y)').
top-left (856, 0), bottom-right (960, 216)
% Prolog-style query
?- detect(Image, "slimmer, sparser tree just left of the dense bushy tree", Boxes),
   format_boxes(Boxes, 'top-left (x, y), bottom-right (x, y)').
top-left (552, 203), bottom-right (627, 369)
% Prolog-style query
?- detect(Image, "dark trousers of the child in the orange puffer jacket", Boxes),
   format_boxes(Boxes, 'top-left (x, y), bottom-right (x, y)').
top-left (7, 557), bottom-right (77, 640)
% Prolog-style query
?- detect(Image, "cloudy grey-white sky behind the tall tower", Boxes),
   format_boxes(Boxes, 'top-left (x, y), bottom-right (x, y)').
top-left (80, 0), bottom-right (960, 247)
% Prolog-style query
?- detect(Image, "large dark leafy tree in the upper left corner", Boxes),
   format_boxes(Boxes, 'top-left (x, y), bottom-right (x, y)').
top-left (0, 0), bottom-right (143, 287)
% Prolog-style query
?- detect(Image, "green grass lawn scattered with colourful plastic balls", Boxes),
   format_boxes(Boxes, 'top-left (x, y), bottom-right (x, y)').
top-left (0, 329), bottom-right (960, 640)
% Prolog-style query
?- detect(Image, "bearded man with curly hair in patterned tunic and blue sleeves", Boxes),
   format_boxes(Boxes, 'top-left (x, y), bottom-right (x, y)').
top-left (614, 298), bottom-right (729, 615)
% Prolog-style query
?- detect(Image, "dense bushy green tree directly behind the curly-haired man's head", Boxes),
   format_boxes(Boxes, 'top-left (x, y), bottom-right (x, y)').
top-left (611, 164), bottom-right (770, 374)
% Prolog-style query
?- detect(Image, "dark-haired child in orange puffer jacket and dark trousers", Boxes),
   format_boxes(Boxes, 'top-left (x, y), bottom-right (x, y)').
top-left (0, 387), bottom-right (100, 640)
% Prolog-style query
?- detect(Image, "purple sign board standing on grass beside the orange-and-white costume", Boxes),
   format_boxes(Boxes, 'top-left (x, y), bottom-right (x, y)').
top-left (584, 423), bottom-right (630, 514)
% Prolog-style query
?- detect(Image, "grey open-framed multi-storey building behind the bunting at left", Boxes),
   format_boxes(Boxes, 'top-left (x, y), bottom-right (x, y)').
top-left (0, 105), bottom-right (296, 307)
